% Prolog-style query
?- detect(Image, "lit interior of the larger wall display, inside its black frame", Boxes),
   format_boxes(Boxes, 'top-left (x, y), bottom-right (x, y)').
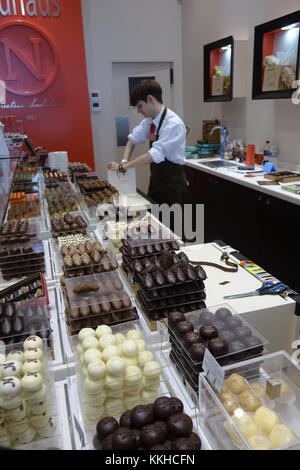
top-left (261, 23), bottom-right (300, 92)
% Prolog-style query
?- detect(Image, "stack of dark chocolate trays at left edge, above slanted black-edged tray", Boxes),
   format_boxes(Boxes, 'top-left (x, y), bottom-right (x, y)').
top-left (0, 240), bottom-right (45, 280)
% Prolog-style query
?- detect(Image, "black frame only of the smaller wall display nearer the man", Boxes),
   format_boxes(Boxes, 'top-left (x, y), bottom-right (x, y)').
top-left (203, 36), bottom-right (234, 103)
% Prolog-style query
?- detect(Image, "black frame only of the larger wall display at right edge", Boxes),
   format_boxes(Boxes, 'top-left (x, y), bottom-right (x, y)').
top-left (252, 10), bottom-right (300, 100)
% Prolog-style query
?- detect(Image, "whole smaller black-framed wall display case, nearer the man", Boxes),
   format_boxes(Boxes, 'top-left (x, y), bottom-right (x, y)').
top-left (204, 36), bottom-right (234, 102)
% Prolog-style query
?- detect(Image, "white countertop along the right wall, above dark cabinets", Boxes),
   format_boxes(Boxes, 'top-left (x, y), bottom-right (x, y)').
top-left (185, 157), bottom-right (300, 206)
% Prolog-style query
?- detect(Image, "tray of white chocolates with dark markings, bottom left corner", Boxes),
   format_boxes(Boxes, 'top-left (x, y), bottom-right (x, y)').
top-left (0, 336), bottom-right (59, 450)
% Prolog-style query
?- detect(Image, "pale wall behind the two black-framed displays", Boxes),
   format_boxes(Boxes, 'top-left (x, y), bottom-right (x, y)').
top-left (182, 0), bottom-right (300, 169)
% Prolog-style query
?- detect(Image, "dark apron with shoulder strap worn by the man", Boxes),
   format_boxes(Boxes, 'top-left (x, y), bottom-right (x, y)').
top-left (148, 107), bottom-right (187, 205)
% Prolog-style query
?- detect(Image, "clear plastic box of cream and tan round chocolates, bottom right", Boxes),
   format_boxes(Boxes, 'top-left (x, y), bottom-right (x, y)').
top-left (199, 351), bottom-right (300, 450)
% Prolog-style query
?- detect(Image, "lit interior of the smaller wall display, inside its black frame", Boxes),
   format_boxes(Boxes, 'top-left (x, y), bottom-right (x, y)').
top-left (210, 45), bottom-right (232, 96)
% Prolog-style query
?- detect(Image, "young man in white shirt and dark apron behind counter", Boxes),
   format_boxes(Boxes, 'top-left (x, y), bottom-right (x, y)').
top-left (107, 80), bottom-right (186, 205)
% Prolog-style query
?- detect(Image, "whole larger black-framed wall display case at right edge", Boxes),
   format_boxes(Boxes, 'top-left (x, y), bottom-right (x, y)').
top-left (252, 10), bottom-right (300, 99)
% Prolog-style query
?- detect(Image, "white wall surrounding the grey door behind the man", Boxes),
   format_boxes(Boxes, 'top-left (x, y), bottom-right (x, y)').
top-left (81, 0), bottom-right (183, 184)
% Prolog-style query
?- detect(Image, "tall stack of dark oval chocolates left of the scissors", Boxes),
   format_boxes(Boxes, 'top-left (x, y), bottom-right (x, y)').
top-left (123, 251), bottom-right (206, 320)
